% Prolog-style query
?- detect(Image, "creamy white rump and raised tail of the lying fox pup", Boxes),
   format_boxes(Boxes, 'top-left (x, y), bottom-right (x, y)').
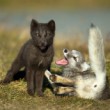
top-left (76, 27), bottom-right (106, 99)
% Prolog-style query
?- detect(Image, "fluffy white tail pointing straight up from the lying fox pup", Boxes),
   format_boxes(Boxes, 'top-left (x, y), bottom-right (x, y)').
top-left (88, 24), bottom-right (106, 80)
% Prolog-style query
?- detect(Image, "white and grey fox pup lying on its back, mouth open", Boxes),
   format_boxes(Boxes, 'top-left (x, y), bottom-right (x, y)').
top-left (45, 24), bottom-right (109, 99)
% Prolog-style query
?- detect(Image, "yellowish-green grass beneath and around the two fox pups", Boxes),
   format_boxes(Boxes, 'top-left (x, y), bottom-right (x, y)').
top-left (0, 32), bottom-right (110, 110)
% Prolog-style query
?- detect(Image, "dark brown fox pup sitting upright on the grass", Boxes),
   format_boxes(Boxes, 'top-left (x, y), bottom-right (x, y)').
top-left (1, 19), bottom-right (55, 96)
